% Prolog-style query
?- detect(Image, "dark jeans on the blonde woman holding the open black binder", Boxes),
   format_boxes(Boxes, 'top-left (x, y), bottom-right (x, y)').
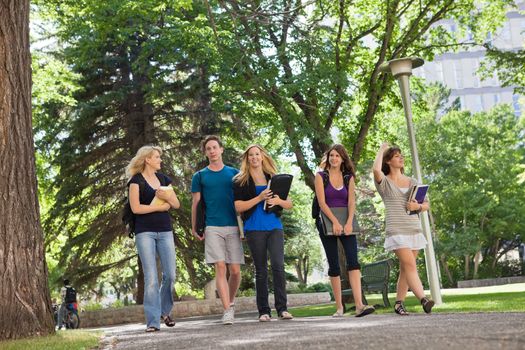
top-left (246, 230), bottom-right (287, 316)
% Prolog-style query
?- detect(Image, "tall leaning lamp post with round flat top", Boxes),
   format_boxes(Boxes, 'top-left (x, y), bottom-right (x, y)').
top-left (379, 57), bottom-right (442, 305)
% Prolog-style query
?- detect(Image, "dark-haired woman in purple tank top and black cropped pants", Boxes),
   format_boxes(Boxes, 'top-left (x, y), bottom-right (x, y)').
top-left (315, 144), bottom-right (375, 317)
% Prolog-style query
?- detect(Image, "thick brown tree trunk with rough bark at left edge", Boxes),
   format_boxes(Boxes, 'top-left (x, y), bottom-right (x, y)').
top-left (0, 0), bottom-right (54, 340)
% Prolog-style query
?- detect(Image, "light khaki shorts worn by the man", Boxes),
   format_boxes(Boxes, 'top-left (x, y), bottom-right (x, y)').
top-left (204, 226), bottom-right (244, 264)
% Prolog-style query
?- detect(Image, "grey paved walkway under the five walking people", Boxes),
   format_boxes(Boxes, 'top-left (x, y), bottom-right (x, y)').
top-left (94, 313), bottom-right (525, 350)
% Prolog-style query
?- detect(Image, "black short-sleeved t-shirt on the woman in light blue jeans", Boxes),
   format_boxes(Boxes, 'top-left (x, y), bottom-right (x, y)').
top-left (129, 173), bottom-right (173, 235)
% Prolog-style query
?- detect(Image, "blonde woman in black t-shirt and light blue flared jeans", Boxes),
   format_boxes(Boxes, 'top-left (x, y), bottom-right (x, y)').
top-left (126, 146), bottom-right (180, 332)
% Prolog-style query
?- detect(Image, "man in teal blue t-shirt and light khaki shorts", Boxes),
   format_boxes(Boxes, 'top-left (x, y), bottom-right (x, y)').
top-left (191, 135), bottom-right (244, 324)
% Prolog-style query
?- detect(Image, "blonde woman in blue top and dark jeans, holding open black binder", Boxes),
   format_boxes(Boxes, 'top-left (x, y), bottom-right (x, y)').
top-left (233, 145), bottom-right (293, 322)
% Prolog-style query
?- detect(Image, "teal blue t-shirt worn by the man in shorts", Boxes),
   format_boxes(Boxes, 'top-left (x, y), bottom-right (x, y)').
top-left (191, 165), bottom-right (239, 227)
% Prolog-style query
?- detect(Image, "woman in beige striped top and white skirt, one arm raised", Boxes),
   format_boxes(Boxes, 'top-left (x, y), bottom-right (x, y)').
top-left (373, 143), bottom-right (434, 316)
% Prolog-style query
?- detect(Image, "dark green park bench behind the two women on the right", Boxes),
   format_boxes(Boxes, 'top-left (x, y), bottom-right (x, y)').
top-left (342, 259), bottom-right (392, 312)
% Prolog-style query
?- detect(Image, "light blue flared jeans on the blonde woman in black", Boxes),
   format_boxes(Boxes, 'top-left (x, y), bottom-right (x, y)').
top-left (135, 231), bottom-right (176, 328)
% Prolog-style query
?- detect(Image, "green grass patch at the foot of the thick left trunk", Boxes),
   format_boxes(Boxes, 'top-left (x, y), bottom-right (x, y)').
top-left (0, 330), bottom-right (101, 350)
